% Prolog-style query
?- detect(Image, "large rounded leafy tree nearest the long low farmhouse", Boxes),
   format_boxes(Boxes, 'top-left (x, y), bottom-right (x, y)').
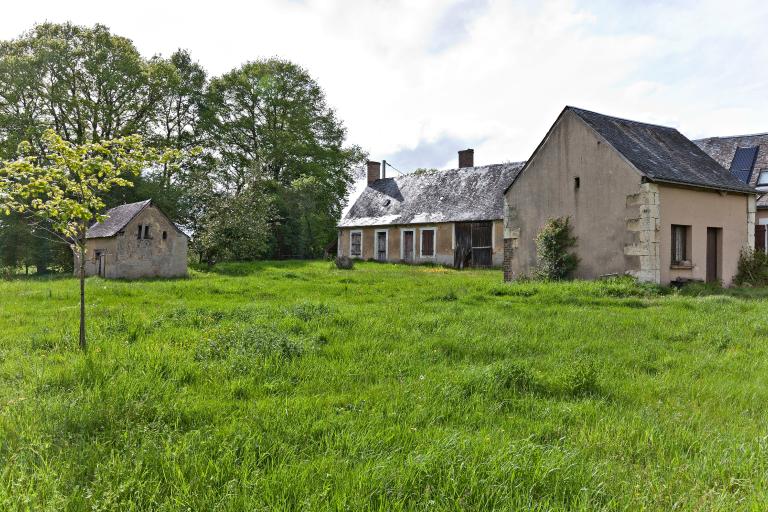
top-left (203, 59), bottom-right (363, 256)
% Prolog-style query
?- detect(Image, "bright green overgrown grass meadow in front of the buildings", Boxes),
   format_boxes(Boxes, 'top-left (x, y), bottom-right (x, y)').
top-left (0, 262), bottom-right (768, 511)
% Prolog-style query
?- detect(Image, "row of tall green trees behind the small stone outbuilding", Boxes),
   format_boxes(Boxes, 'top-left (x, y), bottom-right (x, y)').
top-left (0, 23), bottom-right (365, 272)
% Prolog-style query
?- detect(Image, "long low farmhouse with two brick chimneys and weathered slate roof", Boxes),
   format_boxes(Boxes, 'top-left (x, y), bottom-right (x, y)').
top-left (337, 149), bottom-right (523, 268)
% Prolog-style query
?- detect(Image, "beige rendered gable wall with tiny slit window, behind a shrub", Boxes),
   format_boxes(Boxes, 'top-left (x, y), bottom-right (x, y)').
top-left (504, 112), bottom-right (642, 279)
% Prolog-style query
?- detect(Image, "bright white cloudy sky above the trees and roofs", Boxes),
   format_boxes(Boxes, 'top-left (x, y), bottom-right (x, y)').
top-left (0, 0), bottom-right (768, 170)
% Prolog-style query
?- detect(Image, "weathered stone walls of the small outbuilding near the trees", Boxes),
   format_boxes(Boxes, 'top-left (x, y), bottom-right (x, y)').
top-left (82, 206), bottom-right (187, 279)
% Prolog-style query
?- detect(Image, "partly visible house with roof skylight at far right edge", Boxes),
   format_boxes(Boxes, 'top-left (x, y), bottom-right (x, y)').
top-left (694, 133), bottom-right (768, 252)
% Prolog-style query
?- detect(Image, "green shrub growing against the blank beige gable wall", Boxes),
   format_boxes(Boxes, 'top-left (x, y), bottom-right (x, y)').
top-left (536, 217), bottom-right (579, 281)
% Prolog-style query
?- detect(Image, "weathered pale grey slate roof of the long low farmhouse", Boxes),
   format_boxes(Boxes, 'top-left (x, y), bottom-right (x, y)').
top-left (339, 162), bottom-right (525, 227)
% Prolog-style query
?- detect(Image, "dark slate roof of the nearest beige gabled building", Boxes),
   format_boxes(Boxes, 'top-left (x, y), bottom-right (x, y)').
top-left (565, 107), bottom-right (756, 193)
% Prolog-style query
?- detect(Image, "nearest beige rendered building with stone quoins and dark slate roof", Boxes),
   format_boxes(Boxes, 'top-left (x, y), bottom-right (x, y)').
top-left (504, 107), bottom-right (756, 285)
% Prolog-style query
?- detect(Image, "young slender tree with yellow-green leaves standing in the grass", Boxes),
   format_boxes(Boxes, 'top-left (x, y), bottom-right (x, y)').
top-left (0, 130), bottom-right (157, 350)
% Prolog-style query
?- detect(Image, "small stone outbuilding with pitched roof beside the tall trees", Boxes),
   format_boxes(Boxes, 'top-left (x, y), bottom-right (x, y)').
top-left (75, 200), bottom-right (187, 279)
